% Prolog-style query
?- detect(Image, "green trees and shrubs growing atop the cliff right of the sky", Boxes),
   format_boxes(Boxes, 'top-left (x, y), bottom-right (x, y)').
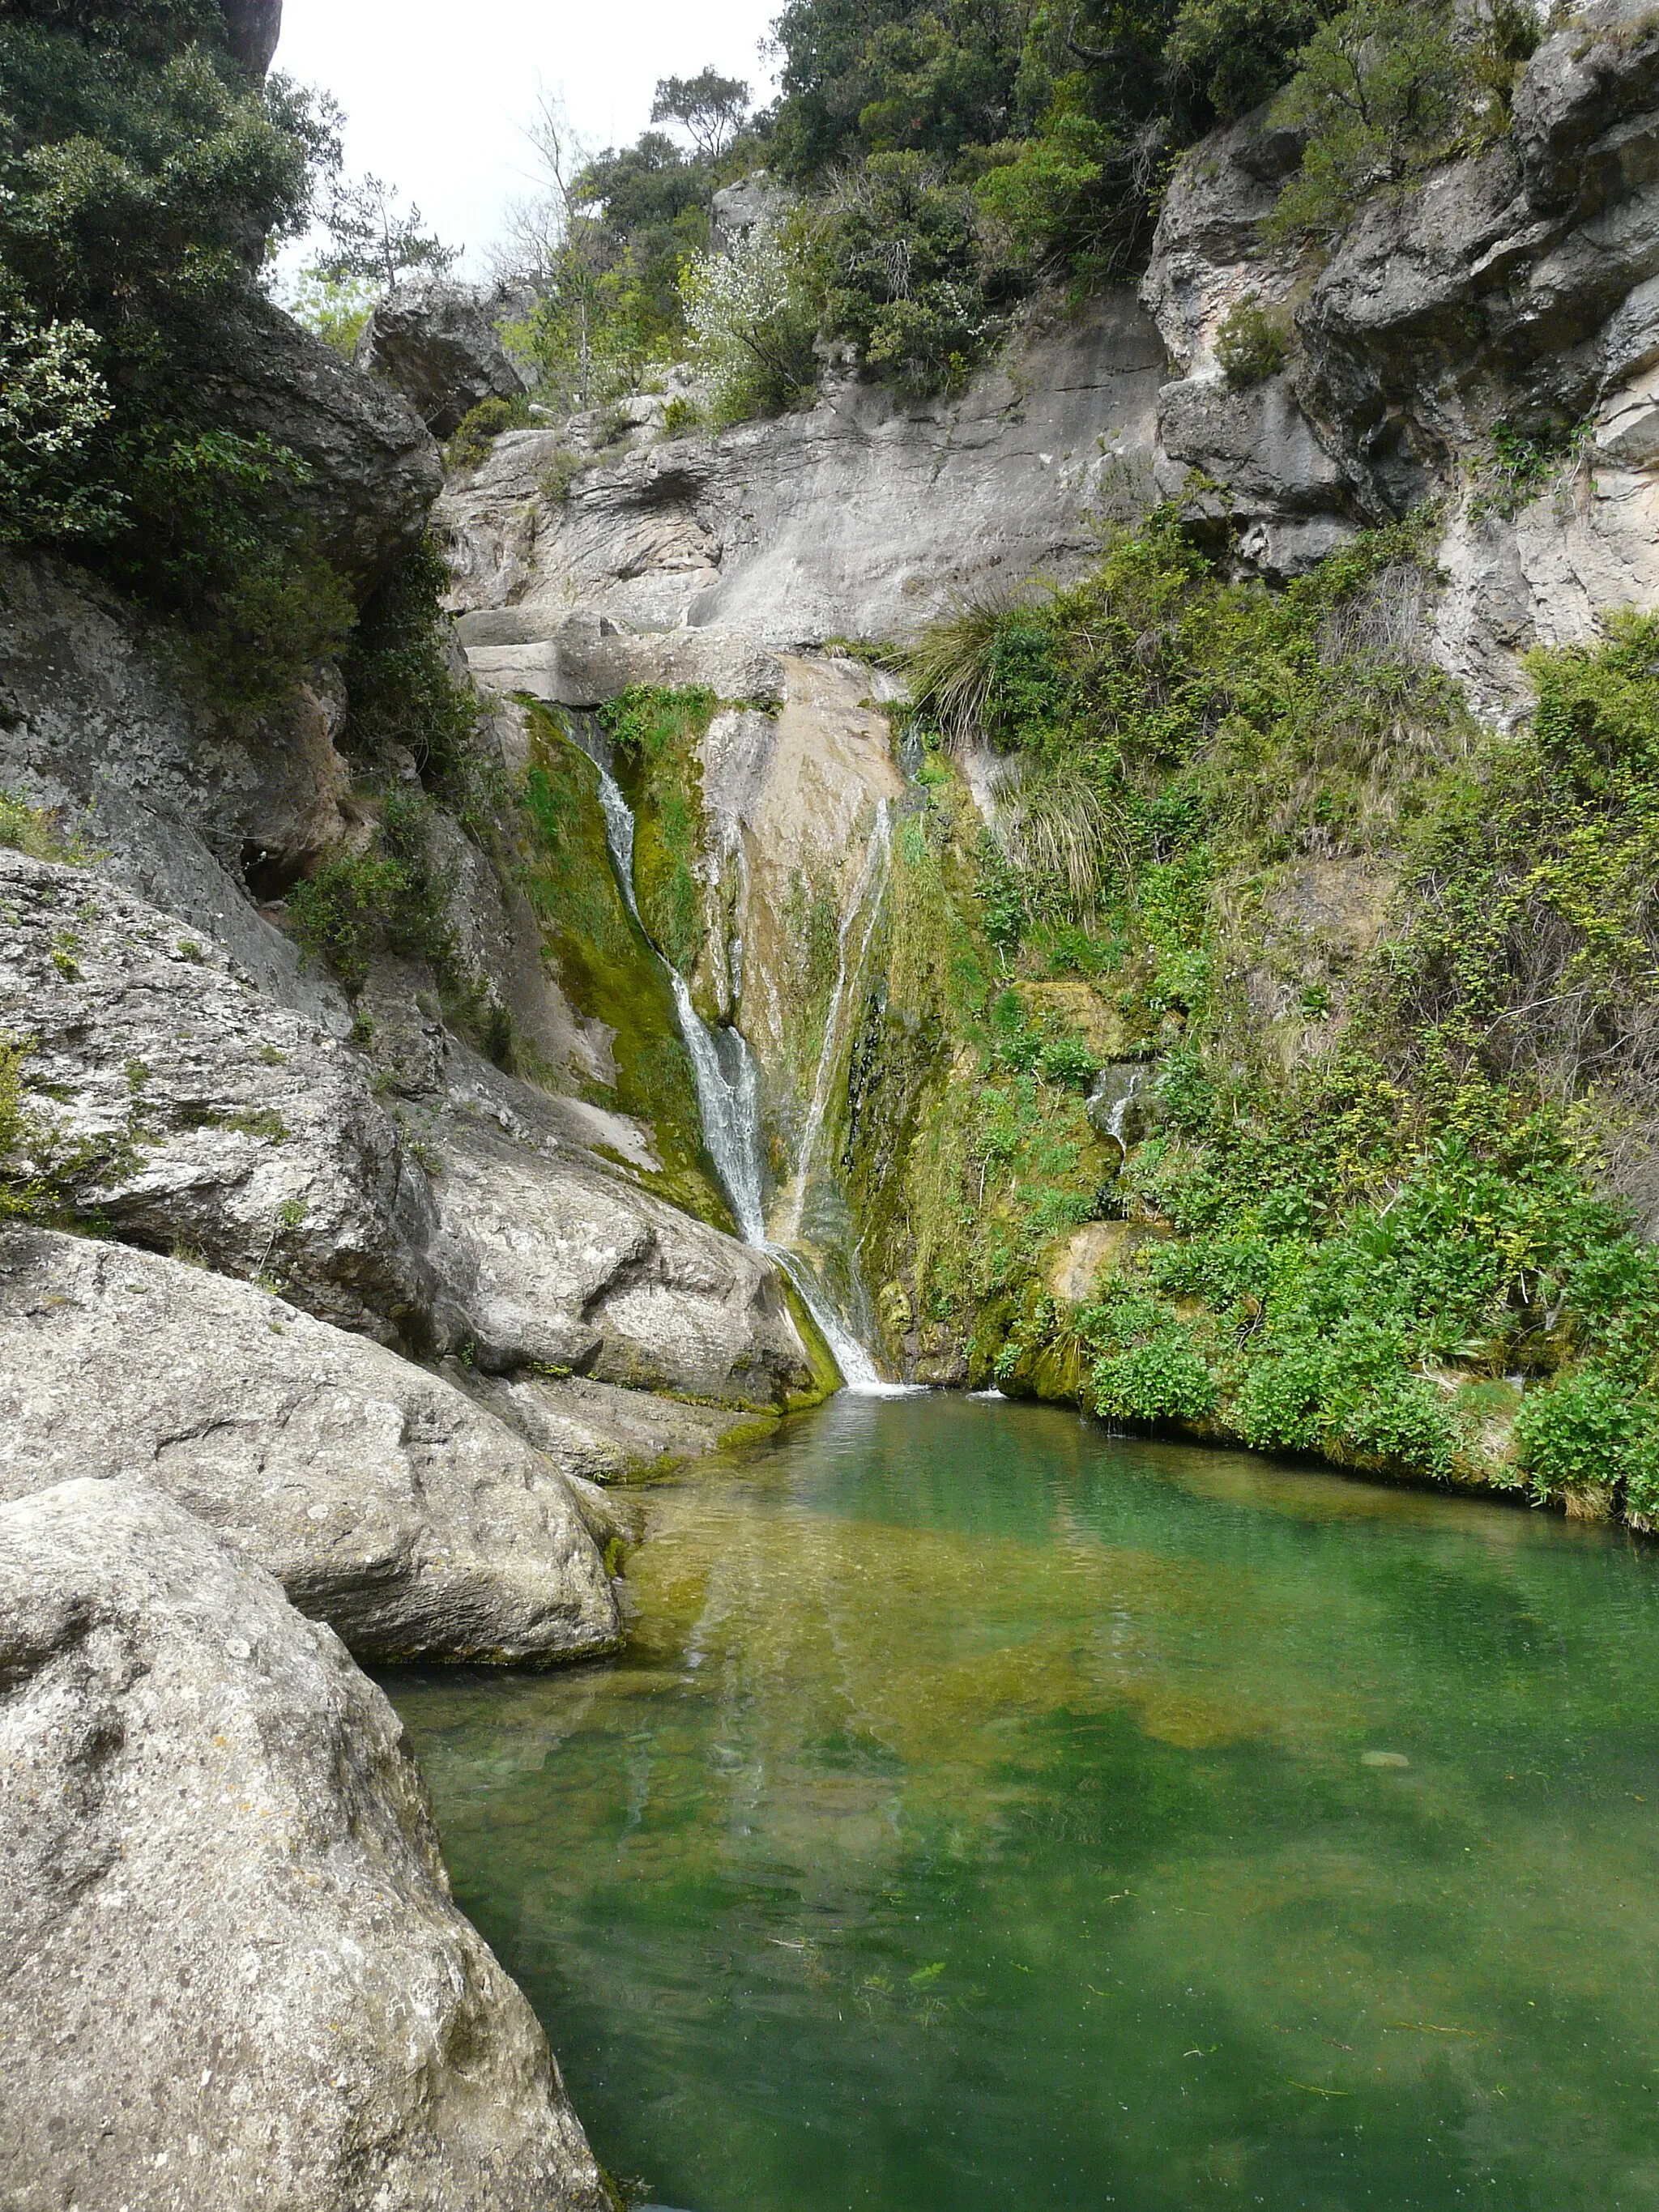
top-left (506, 0), bottom-right (1542, 423)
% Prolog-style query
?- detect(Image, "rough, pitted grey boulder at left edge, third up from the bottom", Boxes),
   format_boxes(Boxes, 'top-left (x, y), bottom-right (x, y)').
top-left (0, 850), bottom-right (449, 1343)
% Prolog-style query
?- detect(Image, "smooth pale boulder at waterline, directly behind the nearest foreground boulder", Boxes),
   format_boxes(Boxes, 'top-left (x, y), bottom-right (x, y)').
top-left (0, 1230), bottom-right (620, 1661)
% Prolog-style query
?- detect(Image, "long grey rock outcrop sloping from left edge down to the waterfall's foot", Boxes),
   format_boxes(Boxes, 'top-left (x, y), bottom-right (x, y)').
top-left (0, 850), bottom-right (812, 1404)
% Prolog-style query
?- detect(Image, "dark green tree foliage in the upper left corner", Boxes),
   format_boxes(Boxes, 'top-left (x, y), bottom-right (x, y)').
top-left (0, 0), bottom-right (348, 676)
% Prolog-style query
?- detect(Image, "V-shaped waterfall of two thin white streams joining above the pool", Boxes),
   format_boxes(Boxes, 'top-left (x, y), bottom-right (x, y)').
top-left (582, 721), bottom-right (902, 1392)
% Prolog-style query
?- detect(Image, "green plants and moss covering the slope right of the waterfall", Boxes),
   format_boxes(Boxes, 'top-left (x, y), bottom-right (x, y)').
top-left (841, 514), bottom-right (1659, 1515)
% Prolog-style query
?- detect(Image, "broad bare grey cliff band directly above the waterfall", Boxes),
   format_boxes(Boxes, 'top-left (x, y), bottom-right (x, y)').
top-left (438, 292), bottom-right (1163, 648)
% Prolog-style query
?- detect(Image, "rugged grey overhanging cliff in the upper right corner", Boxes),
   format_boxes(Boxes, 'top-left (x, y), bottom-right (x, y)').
top-left (1144, 0), bottom-right (1659, 712)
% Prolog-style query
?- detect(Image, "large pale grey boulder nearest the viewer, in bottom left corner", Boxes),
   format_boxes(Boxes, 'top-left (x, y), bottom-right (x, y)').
top-left (0, 1482), bottom-right (608, 2212)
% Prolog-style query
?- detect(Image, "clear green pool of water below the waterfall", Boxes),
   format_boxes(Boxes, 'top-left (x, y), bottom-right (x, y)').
top-left (390, 1398), bottom-right (1659, 2212)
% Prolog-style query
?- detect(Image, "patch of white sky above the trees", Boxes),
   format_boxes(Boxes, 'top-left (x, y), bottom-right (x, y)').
top-left (275, 0), bottom-right (778, 275)
